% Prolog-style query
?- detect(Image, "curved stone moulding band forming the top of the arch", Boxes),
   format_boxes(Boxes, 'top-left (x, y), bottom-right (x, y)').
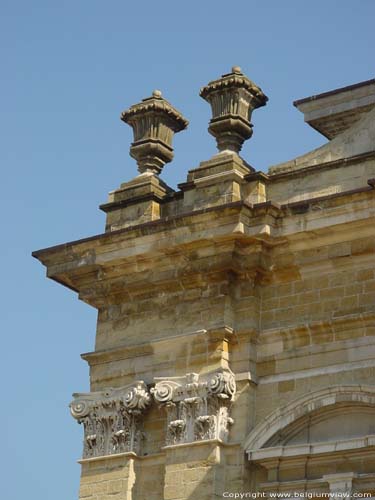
top-left (244, 384), bottom-right (375, 457)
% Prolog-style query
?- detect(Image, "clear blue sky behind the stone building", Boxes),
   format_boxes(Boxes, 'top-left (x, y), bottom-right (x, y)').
top-left (0, 0), bottom-right (375, 500)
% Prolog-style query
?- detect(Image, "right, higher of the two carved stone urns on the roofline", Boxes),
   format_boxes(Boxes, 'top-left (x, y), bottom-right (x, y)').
top-left (200, 66), bottom-right (268, 153)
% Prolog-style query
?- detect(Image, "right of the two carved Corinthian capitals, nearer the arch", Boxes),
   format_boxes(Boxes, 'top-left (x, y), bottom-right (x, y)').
top-left (151, 371), bottom-right (236, 445)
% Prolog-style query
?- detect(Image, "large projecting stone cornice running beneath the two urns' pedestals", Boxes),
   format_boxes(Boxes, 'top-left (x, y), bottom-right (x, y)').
top-left (33, 186), bottom-right (375, 307)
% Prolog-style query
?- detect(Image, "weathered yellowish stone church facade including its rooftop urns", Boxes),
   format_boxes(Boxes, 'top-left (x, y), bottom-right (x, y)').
top-left (33, 67), bottom-right (375, 500)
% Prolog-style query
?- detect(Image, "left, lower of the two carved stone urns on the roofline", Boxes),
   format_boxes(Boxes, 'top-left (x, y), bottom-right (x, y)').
top-left (121, 90), bottom-right (189, 175)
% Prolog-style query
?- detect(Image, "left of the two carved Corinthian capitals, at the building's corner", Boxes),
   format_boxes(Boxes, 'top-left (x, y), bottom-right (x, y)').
top-left (70, 382), bottom-right (151, 458)
